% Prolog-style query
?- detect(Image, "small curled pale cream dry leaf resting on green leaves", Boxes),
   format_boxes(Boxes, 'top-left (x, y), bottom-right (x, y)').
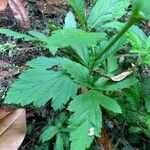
top-left (110, 71), bottom-right (133, 82)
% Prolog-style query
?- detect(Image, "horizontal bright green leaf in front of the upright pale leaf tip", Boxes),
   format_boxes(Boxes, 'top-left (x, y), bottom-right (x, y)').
top-left (46, 29), bottom-right (106, 59)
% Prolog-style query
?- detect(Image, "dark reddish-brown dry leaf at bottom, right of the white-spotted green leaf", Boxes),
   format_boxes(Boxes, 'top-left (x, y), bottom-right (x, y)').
top-left (98, 127), bottom-right (112, 150)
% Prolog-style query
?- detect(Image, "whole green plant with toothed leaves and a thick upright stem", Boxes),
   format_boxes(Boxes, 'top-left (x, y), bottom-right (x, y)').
top-left (0, 0), bottom-right (150, 150)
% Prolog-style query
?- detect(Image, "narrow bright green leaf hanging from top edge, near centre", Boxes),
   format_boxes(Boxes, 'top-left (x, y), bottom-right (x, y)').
top-left (67, 0), bottom-right (85, 24)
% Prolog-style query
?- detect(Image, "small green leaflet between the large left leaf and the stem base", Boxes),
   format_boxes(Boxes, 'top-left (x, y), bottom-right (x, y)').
top-left (64, 59), bottom-right (92, 87)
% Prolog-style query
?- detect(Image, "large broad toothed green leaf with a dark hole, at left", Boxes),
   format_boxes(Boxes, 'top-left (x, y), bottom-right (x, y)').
top-left (5, 57), bottom-right (78, 110)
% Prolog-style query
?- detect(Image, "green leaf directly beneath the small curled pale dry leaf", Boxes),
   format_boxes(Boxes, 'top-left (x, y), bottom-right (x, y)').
top-left (95, 77), bottom-right (138, 91)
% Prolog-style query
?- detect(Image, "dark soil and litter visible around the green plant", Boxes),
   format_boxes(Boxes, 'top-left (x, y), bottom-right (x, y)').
top-left (0, 0), bottom-right (150, 150)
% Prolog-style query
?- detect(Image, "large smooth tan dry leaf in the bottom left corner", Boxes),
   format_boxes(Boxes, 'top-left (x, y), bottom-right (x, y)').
top-left (0, 109), bottom-right (26, 150)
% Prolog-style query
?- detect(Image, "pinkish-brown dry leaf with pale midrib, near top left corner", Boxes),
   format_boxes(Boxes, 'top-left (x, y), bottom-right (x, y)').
top-left (8, 0), bottom-right (30, 28)
